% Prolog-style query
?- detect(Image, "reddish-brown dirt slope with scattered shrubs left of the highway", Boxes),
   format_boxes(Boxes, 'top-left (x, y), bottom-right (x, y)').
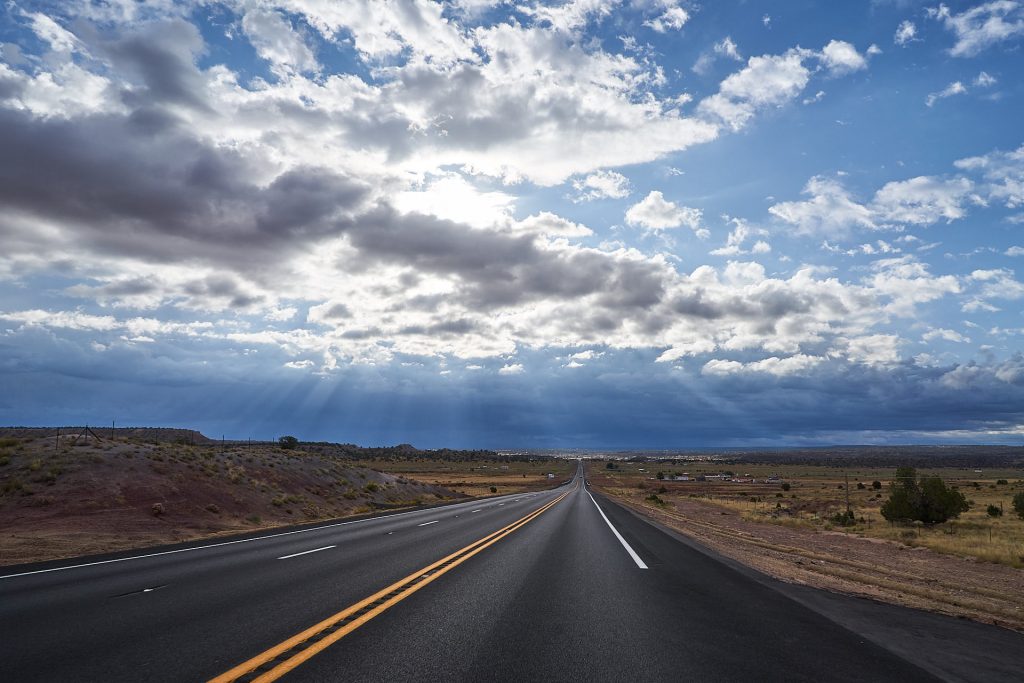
top-left (0, 435), bottom-right (463, 564)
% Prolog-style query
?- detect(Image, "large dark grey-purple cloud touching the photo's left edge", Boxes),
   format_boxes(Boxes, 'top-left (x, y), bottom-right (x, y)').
top-left (0, 110), bottom-right (369, 266)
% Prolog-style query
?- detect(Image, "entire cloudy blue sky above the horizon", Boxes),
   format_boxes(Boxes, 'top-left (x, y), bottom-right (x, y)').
top-left (0, 0), bottom-right (1024, 447)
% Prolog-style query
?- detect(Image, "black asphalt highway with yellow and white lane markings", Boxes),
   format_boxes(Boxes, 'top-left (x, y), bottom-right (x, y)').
top-left (0, 462), bottom-right (1024, 683)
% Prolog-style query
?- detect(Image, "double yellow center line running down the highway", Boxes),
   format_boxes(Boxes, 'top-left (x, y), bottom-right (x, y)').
top-left (210, 490), bottom-right (570, 683)
